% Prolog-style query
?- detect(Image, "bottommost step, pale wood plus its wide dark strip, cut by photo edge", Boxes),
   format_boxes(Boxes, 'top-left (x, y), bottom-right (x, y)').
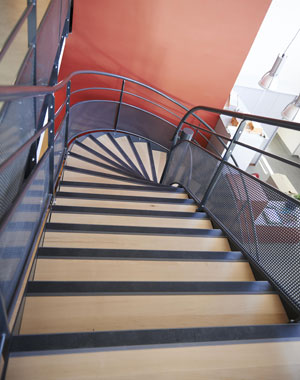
top-left (7, 324), bottom-right (300, 380)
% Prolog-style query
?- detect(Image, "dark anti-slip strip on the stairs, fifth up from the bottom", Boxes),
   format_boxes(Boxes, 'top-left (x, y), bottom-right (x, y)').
top-left (51, 205), bottom-right (208, 219)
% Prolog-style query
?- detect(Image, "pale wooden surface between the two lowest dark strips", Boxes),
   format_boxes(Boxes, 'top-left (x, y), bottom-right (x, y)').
top-left (21, 294), bottom-right (287, 334)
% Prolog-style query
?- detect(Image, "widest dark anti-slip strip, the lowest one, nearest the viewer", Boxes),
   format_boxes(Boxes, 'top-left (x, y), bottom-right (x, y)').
top-left (11, 323), bottom-right (300, 355)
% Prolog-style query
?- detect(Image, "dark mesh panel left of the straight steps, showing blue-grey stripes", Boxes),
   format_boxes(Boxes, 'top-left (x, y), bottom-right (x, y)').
top-left (0, 156), bottom-right (49, 305)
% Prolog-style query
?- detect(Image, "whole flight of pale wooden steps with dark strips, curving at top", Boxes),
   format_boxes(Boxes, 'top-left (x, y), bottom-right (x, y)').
top-left (6, 133), bottom-right (300, 380)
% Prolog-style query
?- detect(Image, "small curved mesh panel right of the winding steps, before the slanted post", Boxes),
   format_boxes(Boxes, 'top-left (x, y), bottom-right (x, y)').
top-left (163, 141), bottom-right (220, 202)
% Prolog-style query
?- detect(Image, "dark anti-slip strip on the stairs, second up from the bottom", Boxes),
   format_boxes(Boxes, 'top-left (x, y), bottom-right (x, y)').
top-left (26, 281), bottom-right (276, 297)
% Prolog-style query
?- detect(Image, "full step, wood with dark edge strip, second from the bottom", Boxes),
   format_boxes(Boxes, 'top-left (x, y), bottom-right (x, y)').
top-left (20, 281), bottom-right (288, 334)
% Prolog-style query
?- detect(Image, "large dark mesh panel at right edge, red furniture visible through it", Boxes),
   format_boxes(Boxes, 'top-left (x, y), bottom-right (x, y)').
top-left (206, 165), bottom-right (300, 309)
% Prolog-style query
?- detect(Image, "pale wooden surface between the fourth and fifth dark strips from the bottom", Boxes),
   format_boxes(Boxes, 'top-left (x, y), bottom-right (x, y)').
top-left (51, 212), bottom-right (212, 228)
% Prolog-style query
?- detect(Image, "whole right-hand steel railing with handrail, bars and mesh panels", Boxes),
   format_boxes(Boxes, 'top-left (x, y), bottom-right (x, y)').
top-left (162, 106), bottom-right (300, 320)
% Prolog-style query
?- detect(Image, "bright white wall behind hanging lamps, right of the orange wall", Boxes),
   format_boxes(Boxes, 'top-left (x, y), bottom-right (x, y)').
top-left (236, 0), bottom-right (300, 95)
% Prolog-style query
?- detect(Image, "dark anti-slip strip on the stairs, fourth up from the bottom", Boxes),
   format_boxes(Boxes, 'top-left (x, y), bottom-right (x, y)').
top-left (46, 223), bottom-right (224, 236)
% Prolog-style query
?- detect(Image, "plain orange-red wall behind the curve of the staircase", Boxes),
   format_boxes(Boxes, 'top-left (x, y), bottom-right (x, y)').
top-left (60, 0), bottom-right (271, 129)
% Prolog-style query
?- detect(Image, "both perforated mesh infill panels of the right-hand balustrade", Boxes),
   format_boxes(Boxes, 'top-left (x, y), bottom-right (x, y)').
top-left (164, 141), bottom-right (300, 310)
